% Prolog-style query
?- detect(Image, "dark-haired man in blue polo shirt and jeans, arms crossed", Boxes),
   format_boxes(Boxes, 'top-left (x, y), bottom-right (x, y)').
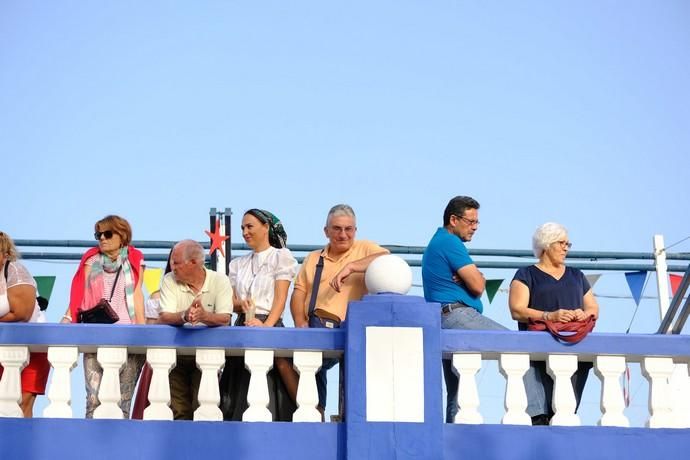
top-left (422, 196), bottom-right (544, 423)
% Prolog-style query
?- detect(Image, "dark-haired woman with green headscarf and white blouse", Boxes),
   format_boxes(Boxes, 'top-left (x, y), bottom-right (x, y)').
top-left (221, 209), bottom-right (297, 421)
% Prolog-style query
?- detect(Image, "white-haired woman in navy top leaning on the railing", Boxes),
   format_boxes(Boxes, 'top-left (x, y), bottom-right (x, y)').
top-left (508, 222), bottom-right (599, 425)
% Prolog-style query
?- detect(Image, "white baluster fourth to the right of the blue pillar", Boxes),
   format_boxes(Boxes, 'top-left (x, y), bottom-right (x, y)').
top-left (594, 356), bottom-right (630, 427)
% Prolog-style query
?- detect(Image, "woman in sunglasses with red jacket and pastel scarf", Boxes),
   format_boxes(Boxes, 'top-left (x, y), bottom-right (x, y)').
top-left (61, 215), bottom-right (146, 418)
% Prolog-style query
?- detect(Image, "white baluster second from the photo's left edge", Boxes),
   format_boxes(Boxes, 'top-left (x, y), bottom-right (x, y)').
top-left (43, 347), bottom-right (79, 418)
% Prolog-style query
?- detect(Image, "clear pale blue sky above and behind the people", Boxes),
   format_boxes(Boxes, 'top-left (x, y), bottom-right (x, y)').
top-left (0, 0), bottom-right (690, 424)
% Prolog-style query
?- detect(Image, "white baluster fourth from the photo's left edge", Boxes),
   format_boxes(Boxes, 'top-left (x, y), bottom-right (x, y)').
top-left (144, 348), bottom-right (177, 420)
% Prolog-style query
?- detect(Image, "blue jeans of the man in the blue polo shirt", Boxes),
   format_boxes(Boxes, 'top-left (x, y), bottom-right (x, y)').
top-left (441, 307), bottom-right (548, 423)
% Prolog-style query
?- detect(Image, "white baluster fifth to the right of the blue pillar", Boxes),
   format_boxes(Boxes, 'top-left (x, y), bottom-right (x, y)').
top-left (642, 358), bottom-right (675, 428)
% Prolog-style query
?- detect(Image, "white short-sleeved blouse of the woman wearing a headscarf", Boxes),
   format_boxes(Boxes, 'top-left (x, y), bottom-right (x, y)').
top-left (228, 247), bottom-right (297, 315)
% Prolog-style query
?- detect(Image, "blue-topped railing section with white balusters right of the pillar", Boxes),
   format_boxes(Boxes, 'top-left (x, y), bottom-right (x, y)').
top-left (442, 330), bottom-right (690, 428)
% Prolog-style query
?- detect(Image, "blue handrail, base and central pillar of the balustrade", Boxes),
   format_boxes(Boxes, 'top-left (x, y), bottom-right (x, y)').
top-left (0, 295), bottom-right (690, 460)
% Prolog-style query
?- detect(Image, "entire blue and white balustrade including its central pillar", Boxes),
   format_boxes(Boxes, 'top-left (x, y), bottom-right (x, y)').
top-left (0, 295), bottom-right (690, 460)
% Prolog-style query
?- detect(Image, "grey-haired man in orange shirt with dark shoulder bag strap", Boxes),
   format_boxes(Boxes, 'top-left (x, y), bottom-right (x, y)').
top-left (290, 204), bottom-right (389, 412)
